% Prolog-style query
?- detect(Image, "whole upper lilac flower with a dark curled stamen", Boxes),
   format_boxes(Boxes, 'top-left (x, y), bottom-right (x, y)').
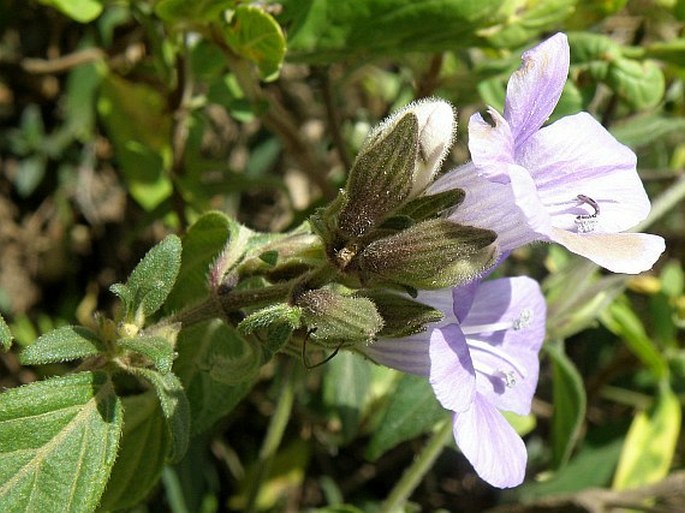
top-left (429, 33), bottom-right (665, 274)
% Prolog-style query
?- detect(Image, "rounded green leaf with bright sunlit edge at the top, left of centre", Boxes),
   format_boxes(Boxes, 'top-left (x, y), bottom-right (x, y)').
top-left (226, 5), bottom-right (285, 80)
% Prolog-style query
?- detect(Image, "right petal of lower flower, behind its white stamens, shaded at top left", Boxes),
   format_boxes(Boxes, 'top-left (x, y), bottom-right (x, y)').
top-left (462, 276), bottom-right (547, 415)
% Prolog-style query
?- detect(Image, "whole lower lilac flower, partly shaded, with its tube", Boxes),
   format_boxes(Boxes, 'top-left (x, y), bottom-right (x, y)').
top-left (364, 277), bottom-right (546, 488)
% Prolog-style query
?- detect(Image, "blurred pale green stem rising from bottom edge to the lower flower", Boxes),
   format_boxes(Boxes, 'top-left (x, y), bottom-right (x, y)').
top-left (380, 420), bottom-right (452, 513)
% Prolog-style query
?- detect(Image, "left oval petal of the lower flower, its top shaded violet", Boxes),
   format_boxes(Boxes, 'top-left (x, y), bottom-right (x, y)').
top-left (429, 324), bottom-right (476, 411)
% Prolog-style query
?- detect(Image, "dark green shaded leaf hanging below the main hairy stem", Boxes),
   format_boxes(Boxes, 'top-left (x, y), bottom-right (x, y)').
top-left (175, 319), bottom-right (257, 434)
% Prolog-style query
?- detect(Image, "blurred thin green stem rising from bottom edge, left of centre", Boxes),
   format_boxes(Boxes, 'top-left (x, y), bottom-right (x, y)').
top-left (245, 359), bottom-right (295, 513)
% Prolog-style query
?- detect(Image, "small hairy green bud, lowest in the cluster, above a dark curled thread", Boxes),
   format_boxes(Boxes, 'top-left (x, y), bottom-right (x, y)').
top-left (295, 289), bottom-right (383, 347)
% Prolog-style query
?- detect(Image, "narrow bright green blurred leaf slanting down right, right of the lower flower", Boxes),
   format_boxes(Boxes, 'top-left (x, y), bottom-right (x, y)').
top-left (600, 301), bottom-right (668, 379)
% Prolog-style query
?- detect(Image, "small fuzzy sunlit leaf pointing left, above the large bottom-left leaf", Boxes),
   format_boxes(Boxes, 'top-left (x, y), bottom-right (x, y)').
top-left (19, 326), bottom-right (105, 365)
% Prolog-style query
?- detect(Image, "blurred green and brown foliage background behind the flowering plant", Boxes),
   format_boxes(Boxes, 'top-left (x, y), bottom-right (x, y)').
top-left (0, 0), bottom-right (685, 513)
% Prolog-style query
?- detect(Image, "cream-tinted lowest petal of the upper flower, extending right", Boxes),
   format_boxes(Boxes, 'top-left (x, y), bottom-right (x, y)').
top-left (551, 228), bottom-right (666, 274)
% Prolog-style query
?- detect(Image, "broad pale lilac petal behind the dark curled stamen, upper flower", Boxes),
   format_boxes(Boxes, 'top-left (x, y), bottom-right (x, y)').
top-left (518, 112), bottom-right (650, 233)
